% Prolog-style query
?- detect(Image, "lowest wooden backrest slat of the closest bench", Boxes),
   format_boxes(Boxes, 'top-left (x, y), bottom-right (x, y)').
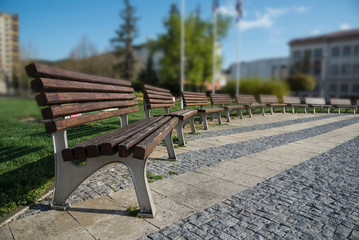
top-left (45, 106), bottom-right (140, 133)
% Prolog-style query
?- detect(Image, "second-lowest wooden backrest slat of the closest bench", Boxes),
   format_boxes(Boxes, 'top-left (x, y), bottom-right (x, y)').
top-left (41, 100), bottom-right (138, 120)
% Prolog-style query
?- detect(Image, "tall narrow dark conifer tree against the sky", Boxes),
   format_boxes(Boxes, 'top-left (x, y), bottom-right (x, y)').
top-left (111, 0), bottom-right (138, 80)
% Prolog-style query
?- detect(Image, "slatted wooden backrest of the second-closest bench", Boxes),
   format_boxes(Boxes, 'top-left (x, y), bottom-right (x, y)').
top-left (141, 84), bottom-right (175, 109)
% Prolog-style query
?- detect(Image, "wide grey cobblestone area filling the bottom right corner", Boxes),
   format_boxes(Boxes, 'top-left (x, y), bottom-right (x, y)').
top-left (141, 137), bottom-right (359, 240)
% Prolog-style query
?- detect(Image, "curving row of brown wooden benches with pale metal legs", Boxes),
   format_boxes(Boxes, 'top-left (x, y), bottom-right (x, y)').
top-left (25, 63), bottom-right (359, 217)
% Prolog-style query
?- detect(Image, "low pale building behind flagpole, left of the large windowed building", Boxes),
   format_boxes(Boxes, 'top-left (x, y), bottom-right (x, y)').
top-left (229, 57), bottom-right (289, 80)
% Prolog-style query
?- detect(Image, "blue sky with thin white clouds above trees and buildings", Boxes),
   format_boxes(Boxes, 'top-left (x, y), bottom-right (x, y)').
top-left (0, 0), bottom-right (359, 69)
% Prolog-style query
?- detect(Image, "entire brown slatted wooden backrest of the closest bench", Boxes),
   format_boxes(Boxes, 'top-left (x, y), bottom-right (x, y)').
top-left (25, 63), bottom-right (139, 133)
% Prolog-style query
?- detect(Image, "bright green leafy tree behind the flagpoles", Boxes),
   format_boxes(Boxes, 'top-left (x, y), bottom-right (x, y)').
top-left (154, 4), bottom-right (231, 93)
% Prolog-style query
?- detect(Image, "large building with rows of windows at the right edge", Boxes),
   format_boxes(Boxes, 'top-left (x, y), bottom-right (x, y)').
top-left (289, 29), bottom-right (359, 100)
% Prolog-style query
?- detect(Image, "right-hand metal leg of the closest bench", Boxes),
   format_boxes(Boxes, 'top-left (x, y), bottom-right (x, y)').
top-left (121, 157), bottom-right (156, 218)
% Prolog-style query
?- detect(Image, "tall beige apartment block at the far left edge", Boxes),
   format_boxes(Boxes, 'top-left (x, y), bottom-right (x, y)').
top-left (0, 12), bottom-right (19, 94)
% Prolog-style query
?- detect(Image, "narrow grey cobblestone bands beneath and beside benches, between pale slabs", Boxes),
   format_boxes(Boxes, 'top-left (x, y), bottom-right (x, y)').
top-left (18, 115), bottom-right (359, 219)
